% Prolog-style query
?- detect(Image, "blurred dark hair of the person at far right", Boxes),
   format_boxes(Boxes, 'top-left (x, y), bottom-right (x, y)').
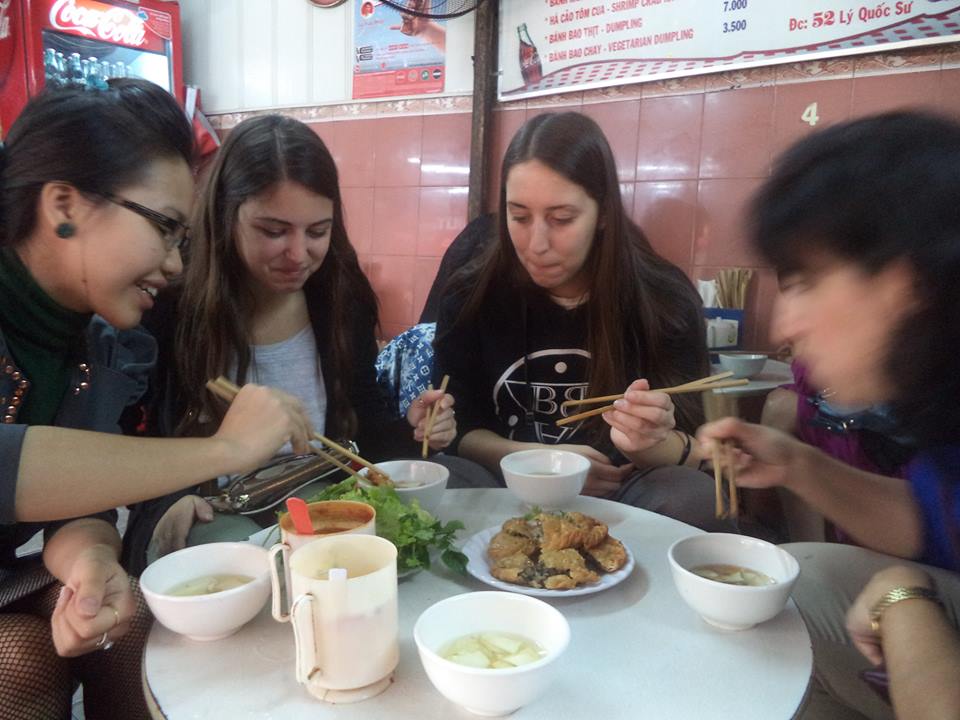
top-left (751, 112), bottom-right (960, 445)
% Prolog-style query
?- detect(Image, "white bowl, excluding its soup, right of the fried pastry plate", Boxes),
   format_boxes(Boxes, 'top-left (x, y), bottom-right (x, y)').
top-left (667, 533), bottom-right (800, 630)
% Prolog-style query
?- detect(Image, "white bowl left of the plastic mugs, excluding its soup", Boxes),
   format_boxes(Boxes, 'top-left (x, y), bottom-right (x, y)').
top-left (140, 542), bottom-right (270, 640)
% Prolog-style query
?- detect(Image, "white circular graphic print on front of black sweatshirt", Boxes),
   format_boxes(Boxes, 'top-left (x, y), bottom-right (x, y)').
top-left (493, 348), bottom-right (590, 445)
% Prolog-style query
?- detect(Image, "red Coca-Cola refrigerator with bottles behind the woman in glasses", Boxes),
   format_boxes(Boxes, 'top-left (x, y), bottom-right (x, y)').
top-left (0, 0), bottom-right (183, 139)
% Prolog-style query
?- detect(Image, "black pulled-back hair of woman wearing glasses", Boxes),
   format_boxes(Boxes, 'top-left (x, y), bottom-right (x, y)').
top-left (0, 78), bottom-right (193, 245)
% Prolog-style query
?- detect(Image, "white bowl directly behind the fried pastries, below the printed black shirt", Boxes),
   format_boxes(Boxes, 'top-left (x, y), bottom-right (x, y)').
top-left (500, 448), bottom-right (590, 510)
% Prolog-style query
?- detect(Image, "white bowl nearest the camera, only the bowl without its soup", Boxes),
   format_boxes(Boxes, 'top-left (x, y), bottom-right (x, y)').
top-left (413, 592), bottom-right (570, 717)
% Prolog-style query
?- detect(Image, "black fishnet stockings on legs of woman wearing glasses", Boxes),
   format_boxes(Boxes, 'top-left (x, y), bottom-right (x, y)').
top-left (0, 578), bottom-right (153, 720)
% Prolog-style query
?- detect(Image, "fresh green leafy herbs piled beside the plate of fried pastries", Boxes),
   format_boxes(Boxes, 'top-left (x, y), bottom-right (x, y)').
top-left (308, 477), bottom-right (467, 575)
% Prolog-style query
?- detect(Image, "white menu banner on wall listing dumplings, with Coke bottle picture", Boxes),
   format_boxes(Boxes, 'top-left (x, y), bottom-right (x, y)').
top-left (499, 0), bottom-right (960, 100)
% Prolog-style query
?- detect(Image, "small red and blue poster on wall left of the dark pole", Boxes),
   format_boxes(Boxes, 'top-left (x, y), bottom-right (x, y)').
top-left (351, 0), bottom-right (446, 100)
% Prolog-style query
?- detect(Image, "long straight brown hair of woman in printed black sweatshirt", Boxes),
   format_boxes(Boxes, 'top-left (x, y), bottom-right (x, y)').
top-left (440, 112), bottom-right (709, 432)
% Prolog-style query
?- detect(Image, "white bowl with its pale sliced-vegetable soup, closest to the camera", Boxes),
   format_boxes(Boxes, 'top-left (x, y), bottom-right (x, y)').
top-left (413, 592), bottom-right (570, 716)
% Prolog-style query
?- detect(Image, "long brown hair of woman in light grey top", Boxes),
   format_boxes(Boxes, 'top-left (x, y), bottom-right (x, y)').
top-left (175, 115), bottom-right (377, 437)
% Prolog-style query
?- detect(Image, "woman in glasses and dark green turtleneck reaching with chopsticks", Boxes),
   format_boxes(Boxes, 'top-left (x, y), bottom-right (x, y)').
top-left (0, 80), bottom-right (310, 719)
